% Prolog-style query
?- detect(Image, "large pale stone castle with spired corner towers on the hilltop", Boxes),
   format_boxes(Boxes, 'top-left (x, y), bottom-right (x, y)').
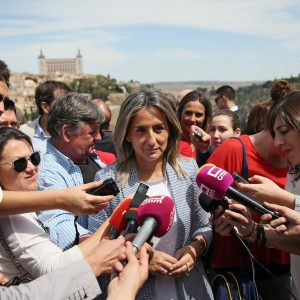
top-left (38, 49), bottom-right (82, 75)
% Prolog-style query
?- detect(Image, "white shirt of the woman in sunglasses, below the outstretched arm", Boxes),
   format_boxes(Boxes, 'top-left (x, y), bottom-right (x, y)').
top-left (0, 213), bottom-right (83, 278)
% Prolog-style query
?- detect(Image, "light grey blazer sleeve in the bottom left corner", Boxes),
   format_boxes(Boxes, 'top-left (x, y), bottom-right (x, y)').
top-left (0, 260), bottom-right (101, 300)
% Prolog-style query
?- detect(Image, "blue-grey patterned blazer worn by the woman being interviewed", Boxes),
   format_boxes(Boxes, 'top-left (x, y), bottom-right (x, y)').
top-left (89, 158), bottom-right (213, 300)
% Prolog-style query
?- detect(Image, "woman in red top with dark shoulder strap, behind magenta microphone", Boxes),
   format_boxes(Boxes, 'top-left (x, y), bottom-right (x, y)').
top-left (207, 101), bottom-right (290, 300)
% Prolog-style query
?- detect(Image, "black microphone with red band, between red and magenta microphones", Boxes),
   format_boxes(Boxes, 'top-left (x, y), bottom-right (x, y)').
top-left (125, 182), bottom-right (149, 236)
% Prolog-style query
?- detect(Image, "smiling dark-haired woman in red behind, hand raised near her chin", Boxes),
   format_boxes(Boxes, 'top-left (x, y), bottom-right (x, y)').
top-left (178, 91), bottom-right (212, 166)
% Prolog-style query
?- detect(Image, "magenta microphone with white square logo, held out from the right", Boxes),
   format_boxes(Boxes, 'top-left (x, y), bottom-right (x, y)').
top-left (196, 164), bottom-right (279, 219)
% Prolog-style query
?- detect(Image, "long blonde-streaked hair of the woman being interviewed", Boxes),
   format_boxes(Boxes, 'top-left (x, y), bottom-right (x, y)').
top-left (114, 89), bottom-right (186, 186)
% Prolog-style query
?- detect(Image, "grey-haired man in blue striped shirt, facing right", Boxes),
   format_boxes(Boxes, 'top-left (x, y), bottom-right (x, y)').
top-left (39, 93), bottom-right (111, 250)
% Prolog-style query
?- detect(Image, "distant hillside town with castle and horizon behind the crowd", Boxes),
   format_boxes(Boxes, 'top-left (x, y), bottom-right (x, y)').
top-left (10, 49), bottom-right (288, 123)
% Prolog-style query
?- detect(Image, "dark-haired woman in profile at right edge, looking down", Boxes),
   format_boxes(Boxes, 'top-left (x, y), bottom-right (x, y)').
top-left (218, 91), bottom-right (300, 299)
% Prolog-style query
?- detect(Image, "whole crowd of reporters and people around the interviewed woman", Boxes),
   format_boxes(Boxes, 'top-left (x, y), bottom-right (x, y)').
top-left (0, 56), bottom-right (300, 300)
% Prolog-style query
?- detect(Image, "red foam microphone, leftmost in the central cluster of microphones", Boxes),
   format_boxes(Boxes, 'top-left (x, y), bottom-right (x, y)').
top-left (105, 195), bottom-right (132, 240)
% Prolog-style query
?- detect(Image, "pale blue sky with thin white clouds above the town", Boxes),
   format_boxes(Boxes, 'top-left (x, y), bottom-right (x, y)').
top-left (0, 0), bottom-right (300, 83)
